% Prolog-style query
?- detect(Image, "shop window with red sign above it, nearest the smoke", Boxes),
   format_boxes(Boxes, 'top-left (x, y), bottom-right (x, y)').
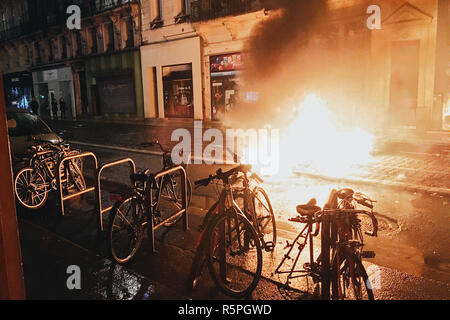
top-left (210, 53), bottom-right (242, 120)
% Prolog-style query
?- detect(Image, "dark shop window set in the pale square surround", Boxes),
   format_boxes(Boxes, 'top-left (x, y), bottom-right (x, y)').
top-left (163, 64), bottom-right (194, 118)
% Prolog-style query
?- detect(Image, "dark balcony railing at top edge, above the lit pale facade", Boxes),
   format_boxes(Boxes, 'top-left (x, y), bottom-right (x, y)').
top-left (187, 0), bottom-right (264, 22)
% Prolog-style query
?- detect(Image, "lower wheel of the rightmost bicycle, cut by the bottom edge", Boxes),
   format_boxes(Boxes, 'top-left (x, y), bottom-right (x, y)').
top-left (333, 248), bottom-right (374, 300)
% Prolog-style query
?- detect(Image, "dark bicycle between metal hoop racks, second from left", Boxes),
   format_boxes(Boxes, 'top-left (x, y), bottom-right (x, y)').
top-left (108, 161), bottom-right (190, 264)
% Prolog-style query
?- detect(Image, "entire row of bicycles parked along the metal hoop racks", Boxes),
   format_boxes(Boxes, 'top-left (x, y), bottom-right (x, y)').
top-left (14, 140), bottom-right (378, 299)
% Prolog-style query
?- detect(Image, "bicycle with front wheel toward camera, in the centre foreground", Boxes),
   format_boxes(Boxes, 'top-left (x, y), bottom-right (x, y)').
top-left (188, 165), bottom-right (262, 298)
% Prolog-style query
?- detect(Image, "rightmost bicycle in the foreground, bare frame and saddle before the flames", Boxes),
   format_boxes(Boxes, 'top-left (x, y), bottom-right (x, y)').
top-left (275, 189), bottom-right (378, 300)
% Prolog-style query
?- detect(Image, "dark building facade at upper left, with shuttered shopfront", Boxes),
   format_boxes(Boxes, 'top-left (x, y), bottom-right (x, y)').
top-left (0, 0), bottom-right (143, 119)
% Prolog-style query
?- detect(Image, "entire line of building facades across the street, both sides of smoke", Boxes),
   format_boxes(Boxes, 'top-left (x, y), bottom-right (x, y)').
top-left (0, 0), bottom-right (450, 131)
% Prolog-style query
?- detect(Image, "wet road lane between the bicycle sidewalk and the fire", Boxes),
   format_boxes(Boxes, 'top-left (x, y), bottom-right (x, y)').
top-left (65, 142), bottom-right (450, 283)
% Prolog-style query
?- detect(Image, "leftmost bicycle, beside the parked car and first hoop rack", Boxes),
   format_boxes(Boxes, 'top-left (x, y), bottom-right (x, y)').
top-left (14, 139), bottom-right (86, 210)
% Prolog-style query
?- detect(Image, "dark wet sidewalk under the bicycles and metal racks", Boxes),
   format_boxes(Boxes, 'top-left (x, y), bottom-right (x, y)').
top-left (19, 186), bottom-right (450, 300)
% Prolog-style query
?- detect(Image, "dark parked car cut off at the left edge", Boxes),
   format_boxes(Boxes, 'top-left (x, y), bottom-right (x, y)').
top-left (6, 108), bottom-right (63, 166)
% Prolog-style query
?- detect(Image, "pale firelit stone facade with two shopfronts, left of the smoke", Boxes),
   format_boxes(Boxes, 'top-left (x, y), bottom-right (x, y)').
top-left (141, 0), bottom-right (267, 120)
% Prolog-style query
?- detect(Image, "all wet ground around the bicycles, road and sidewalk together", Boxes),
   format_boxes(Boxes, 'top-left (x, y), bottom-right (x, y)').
top-left (15, 118), bottom-right (450, 300)
